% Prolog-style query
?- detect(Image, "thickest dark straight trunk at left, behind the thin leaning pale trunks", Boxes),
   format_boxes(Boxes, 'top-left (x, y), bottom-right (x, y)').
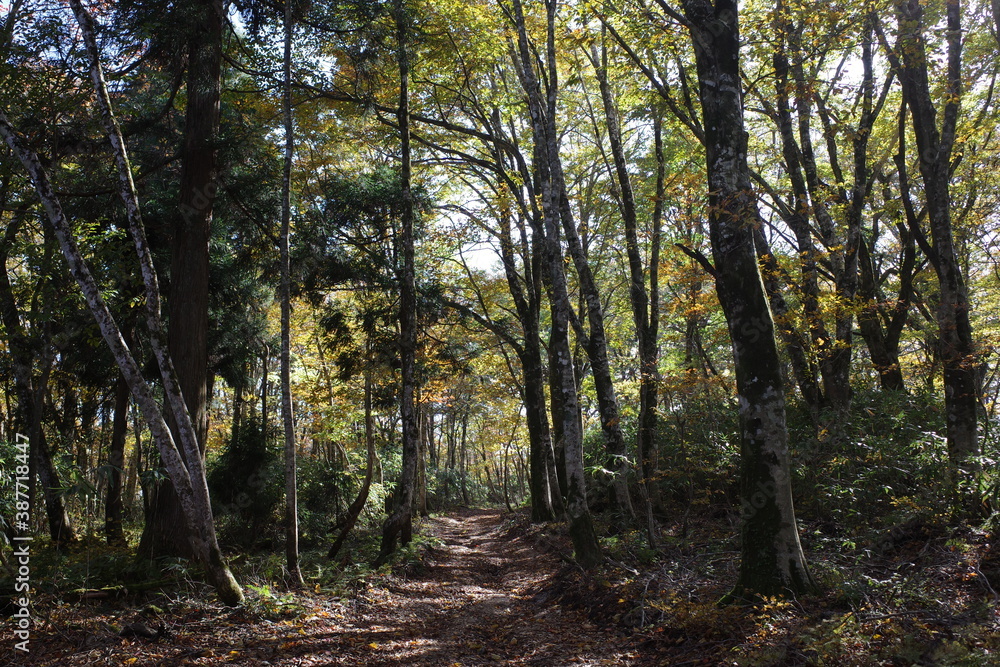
top-left (139, 0), bottom-right (225, 557)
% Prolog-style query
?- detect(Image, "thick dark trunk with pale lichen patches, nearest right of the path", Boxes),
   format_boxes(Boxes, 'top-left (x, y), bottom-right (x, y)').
top-left (678, 0), bottom-right (815, 599)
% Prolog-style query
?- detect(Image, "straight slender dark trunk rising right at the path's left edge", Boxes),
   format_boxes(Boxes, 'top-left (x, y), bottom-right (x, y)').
top-left (378, 0), bottom-right (419, 562)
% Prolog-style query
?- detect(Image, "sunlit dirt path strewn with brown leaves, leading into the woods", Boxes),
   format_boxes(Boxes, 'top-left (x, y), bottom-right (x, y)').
top-left (292, 510), bottom-right (640, 667)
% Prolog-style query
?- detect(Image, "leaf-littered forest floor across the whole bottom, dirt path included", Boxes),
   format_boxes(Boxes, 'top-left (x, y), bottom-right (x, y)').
top-left (0, 509), bottom-right (1000, 667)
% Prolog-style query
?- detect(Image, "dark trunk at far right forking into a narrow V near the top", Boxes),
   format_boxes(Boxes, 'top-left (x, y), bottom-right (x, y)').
top-left (896, 0), bottom-right (980, 466)
